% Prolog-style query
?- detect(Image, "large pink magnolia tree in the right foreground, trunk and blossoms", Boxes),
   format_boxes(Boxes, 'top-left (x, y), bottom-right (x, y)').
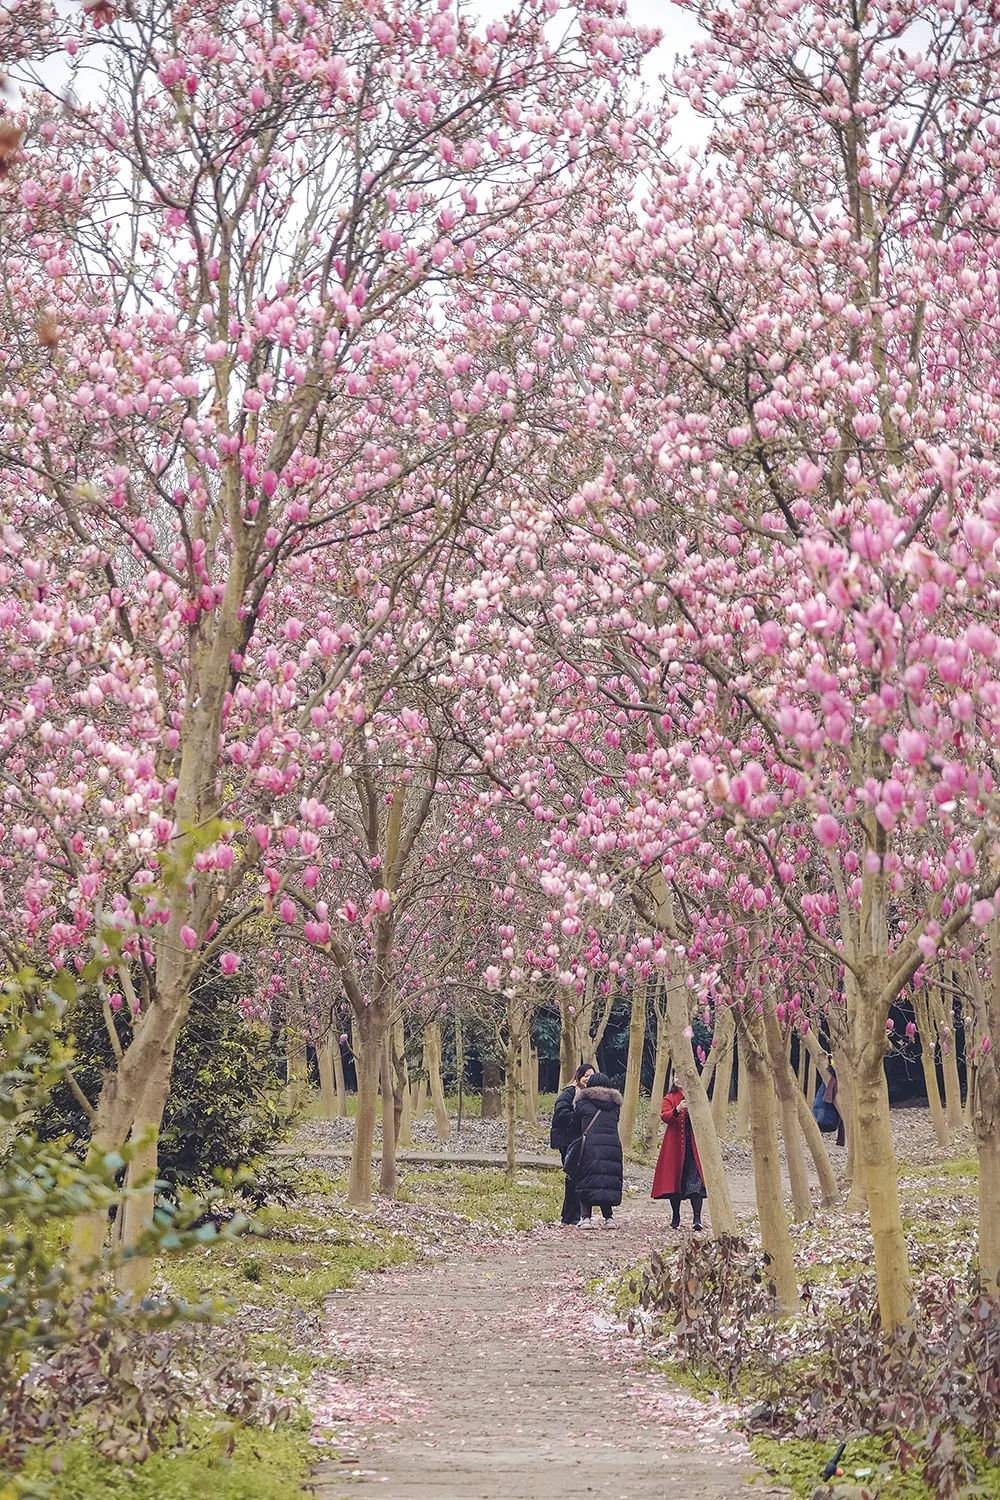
top-left (446, 3), bottom-right (1000, 1328)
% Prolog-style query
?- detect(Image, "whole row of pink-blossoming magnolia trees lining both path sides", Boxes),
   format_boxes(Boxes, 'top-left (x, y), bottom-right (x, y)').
top-left (0, 0), bottom-right (1000, 1326)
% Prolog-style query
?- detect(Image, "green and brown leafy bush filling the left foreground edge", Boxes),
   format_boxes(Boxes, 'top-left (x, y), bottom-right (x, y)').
top-left (0, 974), bottom-right (275, 1494)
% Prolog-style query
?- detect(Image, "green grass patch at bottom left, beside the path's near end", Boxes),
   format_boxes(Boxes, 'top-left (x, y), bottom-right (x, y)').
top-left (15, 1418), bottom-right (315, 1500)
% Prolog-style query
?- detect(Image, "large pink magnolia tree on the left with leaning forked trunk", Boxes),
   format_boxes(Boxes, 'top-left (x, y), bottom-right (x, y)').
top-left (0, 0), bottom-right (656, 1278)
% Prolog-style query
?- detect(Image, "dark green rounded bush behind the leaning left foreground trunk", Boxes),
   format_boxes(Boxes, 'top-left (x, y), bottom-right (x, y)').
top-left (36, 972), bottom-right (288, 1199)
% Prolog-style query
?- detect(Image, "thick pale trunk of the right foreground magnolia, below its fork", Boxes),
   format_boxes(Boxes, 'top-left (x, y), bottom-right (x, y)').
top-left (853, 1041), bottom-right (913, 1332)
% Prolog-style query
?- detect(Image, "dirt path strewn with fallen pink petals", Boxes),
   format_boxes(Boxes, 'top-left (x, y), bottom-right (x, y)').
top-left (308, 1182), bottom-right (768, 1500)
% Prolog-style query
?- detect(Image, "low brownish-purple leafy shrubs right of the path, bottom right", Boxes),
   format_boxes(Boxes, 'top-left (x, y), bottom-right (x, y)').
top-left (630, 1239), bottom-right (1000, 1500)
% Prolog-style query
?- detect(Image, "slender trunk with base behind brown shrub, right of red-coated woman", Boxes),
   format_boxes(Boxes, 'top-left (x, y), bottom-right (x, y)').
top-left (739, 1017), bottom-right (799, 1313)
